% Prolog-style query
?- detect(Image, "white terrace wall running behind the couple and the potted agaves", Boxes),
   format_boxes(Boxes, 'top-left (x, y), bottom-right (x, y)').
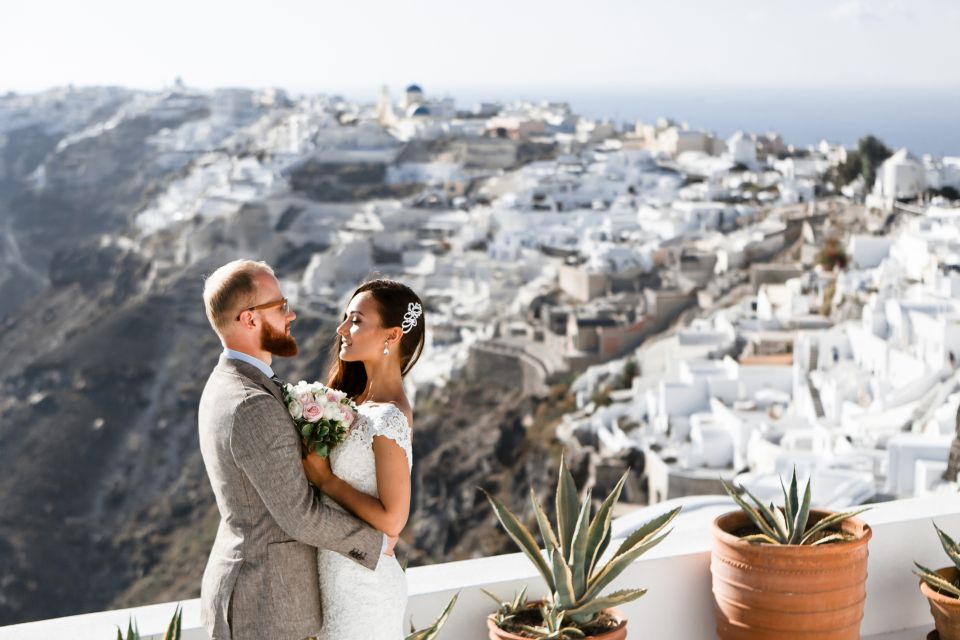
top-left (0, 495), bottom-right (960, 640)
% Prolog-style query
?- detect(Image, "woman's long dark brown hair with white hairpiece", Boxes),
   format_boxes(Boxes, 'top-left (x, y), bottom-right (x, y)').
top-left (327, 279), bottom-right (426, 398)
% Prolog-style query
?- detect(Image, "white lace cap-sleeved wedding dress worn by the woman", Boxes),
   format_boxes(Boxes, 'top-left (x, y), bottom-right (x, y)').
top-left (317, 404), bottom-right (413, 640)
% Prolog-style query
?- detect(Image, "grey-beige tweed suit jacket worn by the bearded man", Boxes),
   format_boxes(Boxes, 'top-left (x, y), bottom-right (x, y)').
top-left (199, 356), bottom-right (383, 640)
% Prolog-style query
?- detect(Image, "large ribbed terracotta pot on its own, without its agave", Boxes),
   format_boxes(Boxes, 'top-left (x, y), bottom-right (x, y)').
top-left (710, 510), bottom-right (872, 640)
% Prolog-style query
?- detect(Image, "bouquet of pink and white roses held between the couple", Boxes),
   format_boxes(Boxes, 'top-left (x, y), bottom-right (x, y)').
top-left (283, 380), bottom-right (357, 457)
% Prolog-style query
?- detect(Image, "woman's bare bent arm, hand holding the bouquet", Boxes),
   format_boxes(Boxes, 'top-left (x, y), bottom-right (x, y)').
top-left (303, 436), bottom-right (410, 536)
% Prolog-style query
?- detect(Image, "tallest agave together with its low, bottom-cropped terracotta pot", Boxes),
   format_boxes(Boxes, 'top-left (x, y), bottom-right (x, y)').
top-left (487, 459), bottom-right (680, 640)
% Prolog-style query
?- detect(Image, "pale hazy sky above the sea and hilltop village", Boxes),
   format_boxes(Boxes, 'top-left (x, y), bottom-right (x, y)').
top-left (0, 0), bottom-right (960, 91)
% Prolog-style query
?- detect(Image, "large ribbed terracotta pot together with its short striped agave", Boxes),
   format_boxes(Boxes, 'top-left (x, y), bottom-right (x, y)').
top-left (710, 469), bottom-right (872, 640)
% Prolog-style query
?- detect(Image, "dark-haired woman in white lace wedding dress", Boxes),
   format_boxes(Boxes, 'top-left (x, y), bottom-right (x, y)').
top-left (303, 280), bottom-right (424, 640)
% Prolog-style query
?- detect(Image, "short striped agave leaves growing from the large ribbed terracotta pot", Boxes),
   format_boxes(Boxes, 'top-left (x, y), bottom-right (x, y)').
top-left (721, 467), bottom-right (868, 545)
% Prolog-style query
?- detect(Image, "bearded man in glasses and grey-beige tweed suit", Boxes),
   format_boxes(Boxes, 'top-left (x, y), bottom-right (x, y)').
top-left (199, 260), bottom-right (396, 640)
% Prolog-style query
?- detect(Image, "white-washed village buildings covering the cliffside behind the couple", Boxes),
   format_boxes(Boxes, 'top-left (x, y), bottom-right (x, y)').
top-left (24, 85), bottom-right (960, 508)
